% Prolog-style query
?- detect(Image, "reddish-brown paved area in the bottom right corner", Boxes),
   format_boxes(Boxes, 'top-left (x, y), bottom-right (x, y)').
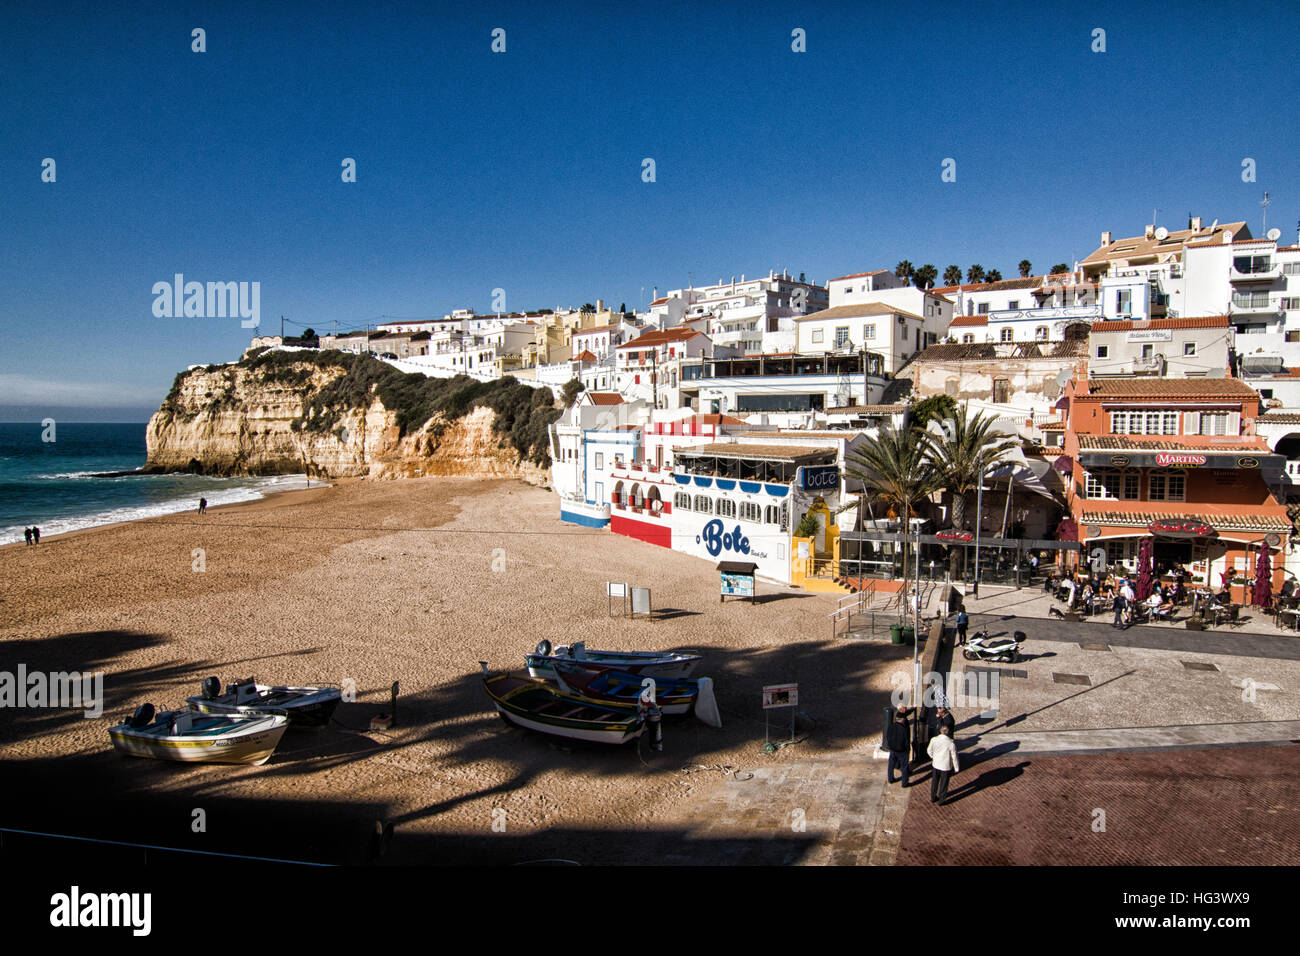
top-left (897, 744), bottom-right (1300, 866)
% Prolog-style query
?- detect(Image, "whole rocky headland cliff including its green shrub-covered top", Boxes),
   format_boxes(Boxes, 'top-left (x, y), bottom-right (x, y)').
top-left (146, 351), bottom-right (558, 484)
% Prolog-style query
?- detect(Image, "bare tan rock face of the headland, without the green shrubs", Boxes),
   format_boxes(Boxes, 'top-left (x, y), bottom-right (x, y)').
top-left (146, 363), bottom-right (549, 484)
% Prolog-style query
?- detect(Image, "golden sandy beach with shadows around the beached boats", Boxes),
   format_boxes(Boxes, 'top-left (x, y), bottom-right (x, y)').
top-left (0, 479), bottom-right (910, 862)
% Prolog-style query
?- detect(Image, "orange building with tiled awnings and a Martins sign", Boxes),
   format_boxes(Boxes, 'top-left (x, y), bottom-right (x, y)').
top-left (1060, 377), bottom-right (1291, 600)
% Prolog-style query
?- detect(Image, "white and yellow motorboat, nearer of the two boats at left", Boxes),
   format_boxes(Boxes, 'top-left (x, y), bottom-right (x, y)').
top-left (108, 704), bottom-right (289, 763)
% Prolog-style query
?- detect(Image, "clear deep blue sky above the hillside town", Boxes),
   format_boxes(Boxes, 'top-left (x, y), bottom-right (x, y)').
top-left (0, 3), bottom-right (1300, 420)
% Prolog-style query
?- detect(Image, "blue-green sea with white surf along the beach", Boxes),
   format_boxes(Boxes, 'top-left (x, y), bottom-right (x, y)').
top-left (0, 421), bottom-right (306, 544)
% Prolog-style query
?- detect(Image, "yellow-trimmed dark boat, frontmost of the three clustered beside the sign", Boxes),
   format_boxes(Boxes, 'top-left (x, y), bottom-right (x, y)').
top-left (484, 666), bottom-right (645, 744)
